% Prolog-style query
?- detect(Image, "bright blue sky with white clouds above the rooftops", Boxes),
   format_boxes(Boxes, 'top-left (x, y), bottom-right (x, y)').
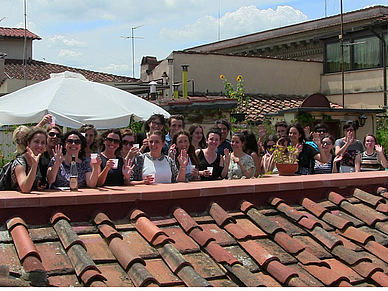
top-left (0, 0), bottom-right (388, 77)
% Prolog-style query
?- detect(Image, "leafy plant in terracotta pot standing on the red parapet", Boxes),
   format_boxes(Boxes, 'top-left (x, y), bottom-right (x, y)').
top-left (273, 145), bottom-right (299, 176)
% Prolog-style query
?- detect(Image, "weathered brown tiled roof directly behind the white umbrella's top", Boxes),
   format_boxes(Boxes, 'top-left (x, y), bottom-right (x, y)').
top-left (4, 59), bottom-right (138, 82)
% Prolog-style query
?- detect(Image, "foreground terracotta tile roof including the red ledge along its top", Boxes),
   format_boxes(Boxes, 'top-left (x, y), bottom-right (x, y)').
top-left (0, 171), bottom-right (388, 287)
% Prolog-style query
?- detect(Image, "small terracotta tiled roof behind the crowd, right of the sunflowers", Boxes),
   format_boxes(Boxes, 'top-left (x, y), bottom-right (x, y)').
top-left (242, 94), bottom-right (342, 121)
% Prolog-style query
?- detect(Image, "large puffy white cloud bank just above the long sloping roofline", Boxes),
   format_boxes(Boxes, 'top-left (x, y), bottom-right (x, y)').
top-left (159, 5), bottom-right (308, 41)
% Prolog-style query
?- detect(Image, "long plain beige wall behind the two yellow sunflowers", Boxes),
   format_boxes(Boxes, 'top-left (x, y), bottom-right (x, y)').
top-left (146, 53), bottom-right (322, 95)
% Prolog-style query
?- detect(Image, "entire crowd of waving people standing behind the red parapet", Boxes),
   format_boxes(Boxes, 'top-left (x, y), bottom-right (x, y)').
top-left (6, 114), bottom-right (387, 193)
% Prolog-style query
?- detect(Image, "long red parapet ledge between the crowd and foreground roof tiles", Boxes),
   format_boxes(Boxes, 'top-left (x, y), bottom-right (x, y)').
top-left (0, 171), bottom-right (388, 225)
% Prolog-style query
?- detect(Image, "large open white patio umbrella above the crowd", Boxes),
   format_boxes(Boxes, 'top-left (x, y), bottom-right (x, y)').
top-left (0, 72), bottom-right (170, 129)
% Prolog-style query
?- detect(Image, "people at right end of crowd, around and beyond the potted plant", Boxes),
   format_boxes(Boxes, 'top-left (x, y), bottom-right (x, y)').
top-left (262, 120), bottom-right (388, 175)
